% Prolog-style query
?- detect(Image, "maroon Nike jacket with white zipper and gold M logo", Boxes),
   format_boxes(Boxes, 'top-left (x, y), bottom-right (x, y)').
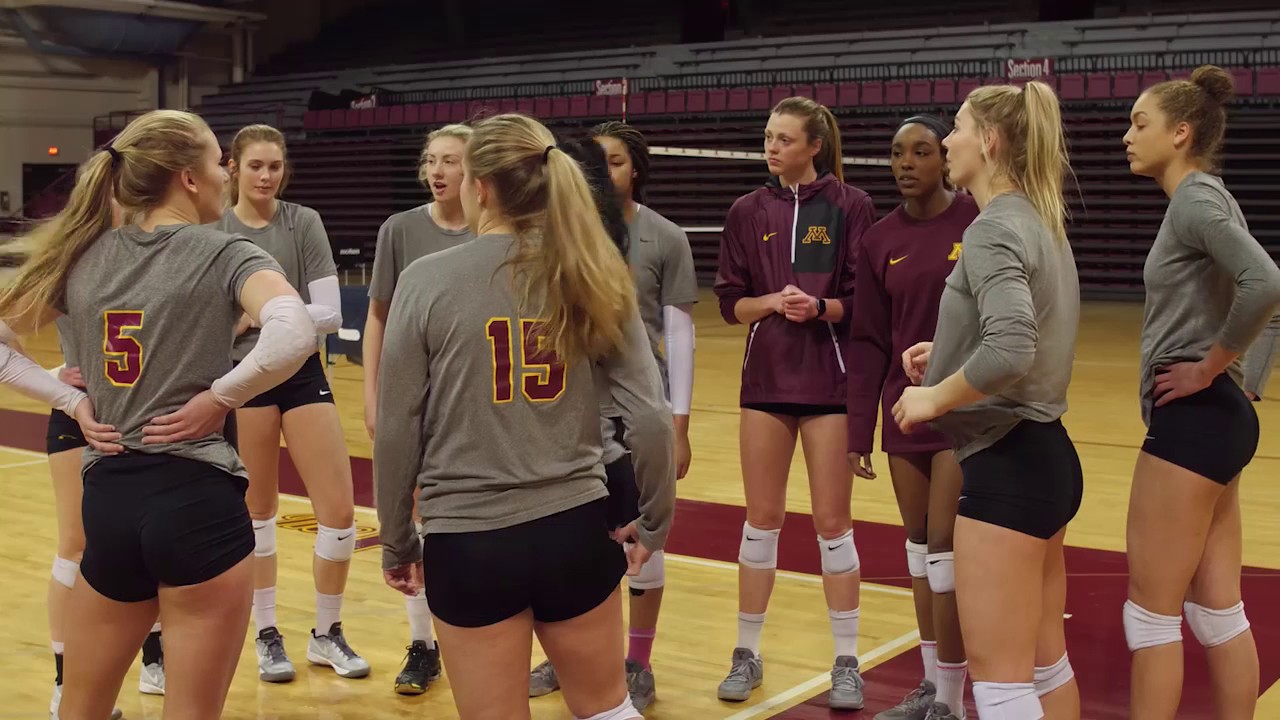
top-left (716, 173), bottom-right (876, 406)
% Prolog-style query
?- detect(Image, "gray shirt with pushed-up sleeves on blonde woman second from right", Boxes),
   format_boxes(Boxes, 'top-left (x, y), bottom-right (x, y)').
top-left (924, 193), bottom-right (1080, 460)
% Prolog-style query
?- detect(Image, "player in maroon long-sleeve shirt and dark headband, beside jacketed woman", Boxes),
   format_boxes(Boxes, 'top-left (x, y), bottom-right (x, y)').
top-left (849, 115), bottom-right (978, 720)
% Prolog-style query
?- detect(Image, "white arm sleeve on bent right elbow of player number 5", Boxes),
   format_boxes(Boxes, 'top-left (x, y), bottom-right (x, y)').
top-left (210, 295), bottom-right (316, 407)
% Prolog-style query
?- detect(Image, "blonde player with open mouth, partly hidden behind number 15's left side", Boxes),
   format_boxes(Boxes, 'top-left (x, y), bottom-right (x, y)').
top-left (362, 124), bottom-right (474, 694)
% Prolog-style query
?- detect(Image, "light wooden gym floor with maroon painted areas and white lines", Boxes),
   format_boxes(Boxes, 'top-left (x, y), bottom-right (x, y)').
top-left (0, 291), bottom-right (1280, 720)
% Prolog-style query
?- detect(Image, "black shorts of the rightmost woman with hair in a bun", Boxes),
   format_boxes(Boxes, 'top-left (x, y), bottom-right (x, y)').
top-left (1142, 374), bottom-right (1258, 486)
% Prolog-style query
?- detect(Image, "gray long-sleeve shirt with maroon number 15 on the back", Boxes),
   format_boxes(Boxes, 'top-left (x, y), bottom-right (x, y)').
top-left (374, 234), bottom-right (676, 568)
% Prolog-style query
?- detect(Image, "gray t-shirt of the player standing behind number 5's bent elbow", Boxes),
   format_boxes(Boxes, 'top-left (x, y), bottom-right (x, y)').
top-left (215, 200), bottom-right (338, 363)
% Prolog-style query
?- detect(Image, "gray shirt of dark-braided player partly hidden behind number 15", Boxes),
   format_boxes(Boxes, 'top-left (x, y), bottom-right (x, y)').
top-left (600, 205), bottom-right (698, 464)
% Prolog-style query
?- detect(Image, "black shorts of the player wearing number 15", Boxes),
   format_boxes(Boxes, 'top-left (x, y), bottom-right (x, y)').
top-left (422, 498), bottom-right (627, 628)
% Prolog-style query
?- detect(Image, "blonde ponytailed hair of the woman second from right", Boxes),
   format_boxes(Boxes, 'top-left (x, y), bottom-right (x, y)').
top-left (966, 81), bottom-right (1071, 241)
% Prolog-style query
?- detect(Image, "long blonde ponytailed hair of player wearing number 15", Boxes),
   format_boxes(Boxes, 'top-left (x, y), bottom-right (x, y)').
top-left (466, 114), bottom-right (636, 361)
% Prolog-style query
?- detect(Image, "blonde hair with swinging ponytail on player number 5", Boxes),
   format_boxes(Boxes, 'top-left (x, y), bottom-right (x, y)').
top-left (0, 110), bottom-right (209, 320)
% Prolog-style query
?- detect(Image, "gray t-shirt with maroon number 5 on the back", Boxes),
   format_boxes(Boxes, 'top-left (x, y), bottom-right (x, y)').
top-left (58, 225), bottom-right (280, 478)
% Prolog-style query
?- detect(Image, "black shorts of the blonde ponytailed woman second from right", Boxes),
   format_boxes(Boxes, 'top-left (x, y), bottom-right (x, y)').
top-left (959, 420), bottom-right (1084, 539)
